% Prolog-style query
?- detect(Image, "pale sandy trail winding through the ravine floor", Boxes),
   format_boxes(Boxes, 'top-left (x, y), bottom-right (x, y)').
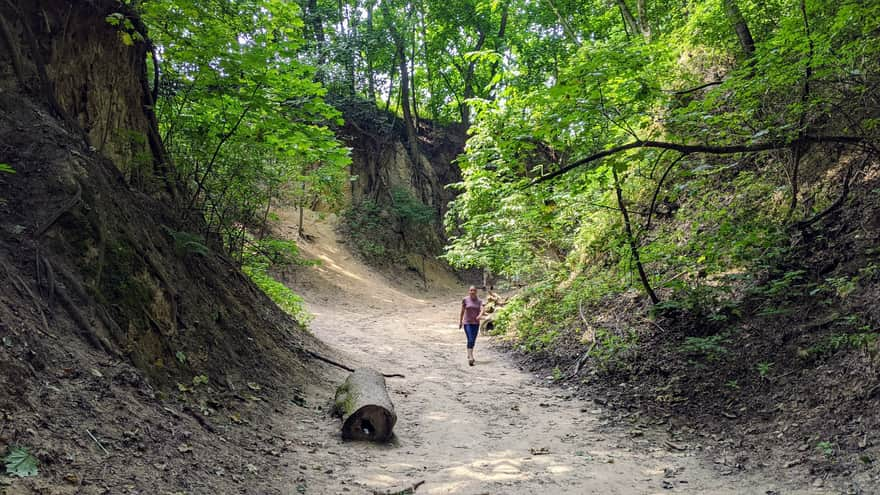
top-left (279, 211), bottom-right (817, 495)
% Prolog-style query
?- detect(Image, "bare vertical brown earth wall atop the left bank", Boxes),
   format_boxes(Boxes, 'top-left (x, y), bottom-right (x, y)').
top-left (0, 0), bottom-right (166, 191)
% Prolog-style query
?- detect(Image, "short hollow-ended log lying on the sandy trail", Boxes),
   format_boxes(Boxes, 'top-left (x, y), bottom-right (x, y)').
top-left (335, 368), bottom-right (397, 442)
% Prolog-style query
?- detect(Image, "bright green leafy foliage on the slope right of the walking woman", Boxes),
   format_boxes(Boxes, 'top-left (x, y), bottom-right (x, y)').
top-left (434, 0), bottom-right (880, 356)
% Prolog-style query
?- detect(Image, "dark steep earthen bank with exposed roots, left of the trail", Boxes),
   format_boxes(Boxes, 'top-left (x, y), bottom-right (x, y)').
top-left (0, 0), bottom-right (338, 493)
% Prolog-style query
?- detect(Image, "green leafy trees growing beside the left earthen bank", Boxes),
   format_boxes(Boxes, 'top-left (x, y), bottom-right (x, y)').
top-left (136, 0), bottom-right (351, 324)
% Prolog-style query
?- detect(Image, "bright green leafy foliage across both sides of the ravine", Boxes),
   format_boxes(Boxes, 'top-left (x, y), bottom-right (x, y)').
top-left (127, 0), bottom-right (880, 356)
